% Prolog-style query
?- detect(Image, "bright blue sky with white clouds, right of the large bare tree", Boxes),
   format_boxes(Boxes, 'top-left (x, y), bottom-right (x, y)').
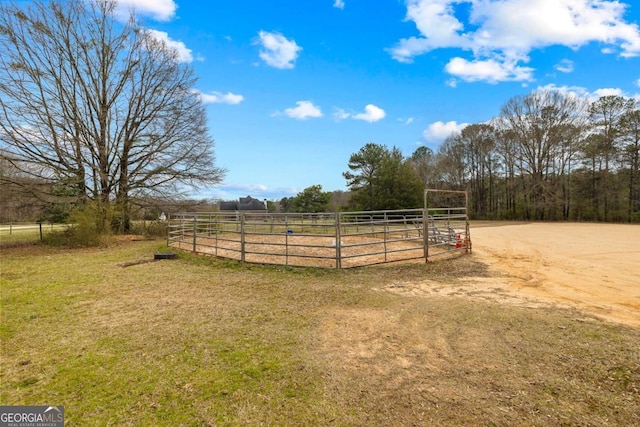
top-left (120, 0), bottom-right (640, 200)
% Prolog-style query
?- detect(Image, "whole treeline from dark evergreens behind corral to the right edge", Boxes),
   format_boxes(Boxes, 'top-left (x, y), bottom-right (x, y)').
top-left (292, 90), bottom-right (640, 222)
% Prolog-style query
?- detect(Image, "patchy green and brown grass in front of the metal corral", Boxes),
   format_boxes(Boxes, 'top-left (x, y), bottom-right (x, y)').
top-left (0, 236), bottom-right (640, 426)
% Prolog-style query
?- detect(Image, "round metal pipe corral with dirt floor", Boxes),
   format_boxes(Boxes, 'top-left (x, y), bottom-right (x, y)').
top-left (167, 192), bottom-right (471, 268)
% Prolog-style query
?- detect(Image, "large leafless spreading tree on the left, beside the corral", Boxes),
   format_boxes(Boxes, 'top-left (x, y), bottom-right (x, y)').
top-left (0, 0), bottom-right (224, 230)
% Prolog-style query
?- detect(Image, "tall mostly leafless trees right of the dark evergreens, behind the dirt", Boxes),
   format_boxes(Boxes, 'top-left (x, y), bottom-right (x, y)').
top-left (436, 91), bottom-right (640, 222)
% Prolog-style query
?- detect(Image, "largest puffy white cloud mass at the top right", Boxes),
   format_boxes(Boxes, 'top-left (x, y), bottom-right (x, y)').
top-left (389, 0), bottom-right (640, 82)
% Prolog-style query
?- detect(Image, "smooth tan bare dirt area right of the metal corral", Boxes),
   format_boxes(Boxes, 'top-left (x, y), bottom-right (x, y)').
top-left (471, 223), bottom-right (640, 327)
